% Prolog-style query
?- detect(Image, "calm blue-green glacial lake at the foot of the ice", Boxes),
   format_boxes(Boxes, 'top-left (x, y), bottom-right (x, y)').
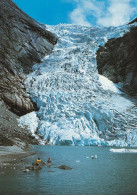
top-left (0, 146), bottom-right (137, 195)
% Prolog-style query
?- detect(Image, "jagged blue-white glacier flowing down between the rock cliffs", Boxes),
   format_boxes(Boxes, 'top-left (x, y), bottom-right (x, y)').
top-left (18, 24), bottom-right (137, 146)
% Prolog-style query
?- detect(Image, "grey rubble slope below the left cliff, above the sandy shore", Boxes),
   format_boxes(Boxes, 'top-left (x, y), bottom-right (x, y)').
top-left (0, 101), bottom-right (38, 146)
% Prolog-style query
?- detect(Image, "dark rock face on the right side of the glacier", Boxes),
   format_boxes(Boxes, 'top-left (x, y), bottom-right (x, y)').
top-left (97, 19), bottom-right (137, 96)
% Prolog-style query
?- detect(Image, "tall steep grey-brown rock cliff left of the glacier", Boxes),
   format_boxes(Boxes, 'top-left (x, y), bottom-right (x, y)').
top-left (0, 0), bottom-right (57, 116)
